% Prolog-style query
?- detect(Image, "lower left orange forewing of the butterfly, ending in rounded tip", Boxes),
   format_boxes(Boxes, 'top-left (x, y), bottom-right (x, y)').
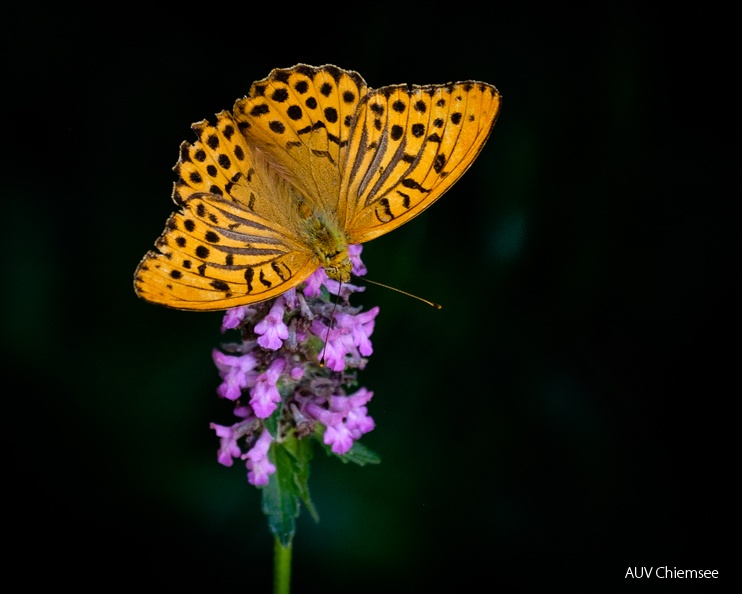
top-left (137, 194), bottom-right (317, 310)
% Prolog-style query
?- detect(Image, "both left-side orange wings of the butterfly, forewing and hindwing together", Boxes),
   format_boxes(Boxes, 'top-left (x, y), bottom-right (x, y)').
top-left (135, 112), bottom-right (317, 310)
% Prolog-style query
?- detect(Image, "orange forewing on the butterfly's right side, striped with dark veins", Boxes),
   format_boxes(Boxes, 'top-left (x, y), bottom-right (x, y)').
top-left (340, 82), bottom-right (500, 243)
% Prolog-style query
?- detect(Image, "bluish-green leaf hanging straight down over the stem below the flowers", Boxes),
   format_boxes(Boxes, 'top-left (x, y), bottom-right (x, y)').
top-left (263, 442), bottom-right (300, 547)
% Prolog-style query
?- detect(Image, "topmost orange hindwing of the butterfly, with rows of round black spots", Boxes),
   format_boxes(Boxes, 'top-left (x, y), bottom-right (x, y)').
top-left (234, 64), bottom-right (367, 210)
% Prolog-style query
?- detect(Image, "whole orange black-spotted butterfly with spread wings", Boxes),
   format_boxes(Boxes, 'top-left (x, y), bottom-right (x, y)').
top-left (134, 64), bottom-right (501, 310)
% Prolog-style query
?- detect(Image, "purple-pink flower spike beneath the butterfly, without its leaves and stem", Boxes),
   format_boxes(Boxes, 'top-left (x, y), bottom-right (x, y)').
top-left (211, 246), bottom-right (379, 486)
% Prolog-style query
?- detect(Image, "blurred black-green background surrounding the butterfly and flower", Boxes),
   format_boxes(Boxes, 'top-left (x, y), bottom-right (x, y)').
top-left (0, 3), bottom-right (739, 592)
